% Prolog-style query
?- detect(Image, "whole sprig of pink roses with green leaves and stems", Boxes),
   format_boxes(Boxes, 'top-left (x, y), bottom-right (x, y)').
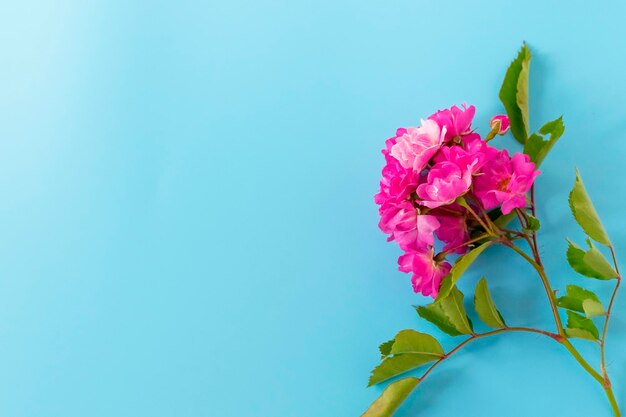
top-left (363, 45), bottom-right (621, 417)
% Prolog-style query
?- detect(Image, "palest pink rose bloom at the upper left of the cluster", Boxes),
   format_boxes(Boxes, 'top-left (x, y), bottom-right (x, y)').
top-left (390, 120), bottom-right (446, 172)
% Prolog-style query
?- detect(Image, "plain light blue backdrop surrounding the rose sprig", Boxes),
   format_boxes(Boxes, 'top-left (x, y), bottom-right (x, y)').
top-left (0, 0), bottom-right (626, 417)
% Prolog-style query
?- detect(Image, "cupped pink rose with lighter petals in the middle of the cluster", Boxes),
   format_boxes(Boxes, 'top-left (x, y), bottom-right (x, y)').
top-left (417, 161), bottom-right (473, 208)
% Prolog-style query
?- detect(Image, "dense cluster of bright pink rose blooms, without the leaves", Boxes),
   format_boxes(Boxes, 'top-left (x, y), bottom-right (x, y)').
top-left (374, 106), bottom-right (539, 298)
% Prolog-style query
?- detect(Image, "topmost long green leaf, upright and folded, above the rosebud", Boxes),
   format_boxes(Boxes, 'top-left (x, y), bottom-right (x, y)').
top-left (499, 44), bottom-right (531, 144)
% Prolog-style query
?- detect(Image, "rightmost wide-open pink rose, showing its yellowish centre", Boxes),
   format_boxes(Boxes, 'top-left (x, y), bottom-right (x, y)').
top-left (474, 150), bottom-right (540, 214)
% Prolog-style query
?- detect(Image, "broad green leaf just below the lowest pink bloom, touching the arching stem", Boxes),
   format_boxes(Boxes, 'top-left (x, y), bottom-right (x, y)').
top-left (416, 287), bottom-right (474, 336)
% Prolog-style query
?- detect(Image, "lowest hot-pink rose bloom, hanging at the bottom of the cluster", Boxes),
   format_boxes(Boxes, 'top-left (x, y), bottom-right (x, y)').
top-left (398, 248), bottom-right (451, 298)
